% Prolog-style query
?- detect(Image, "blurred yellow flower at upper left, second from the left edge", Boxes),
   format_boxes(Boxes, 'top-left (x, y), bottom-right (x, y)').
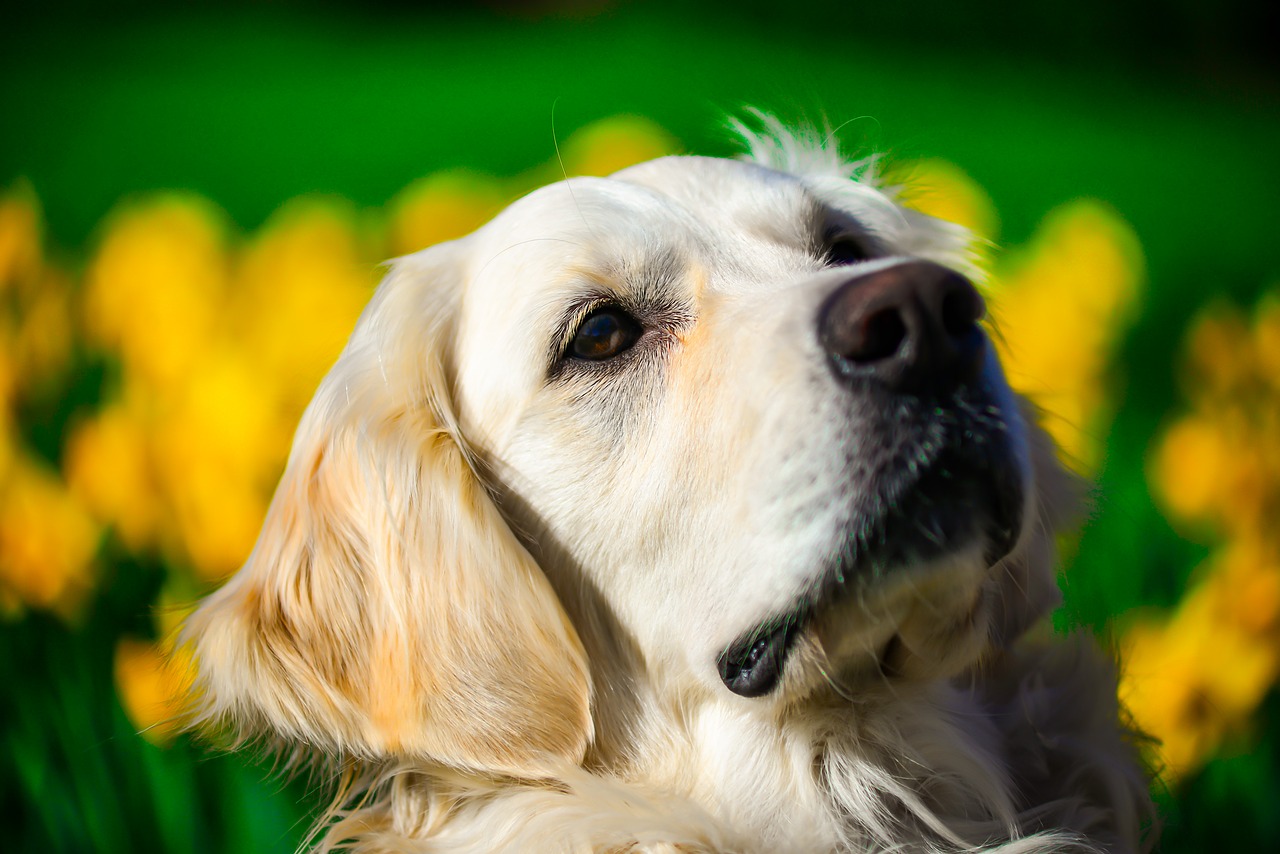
top-left (83, 196), bottom-right (227, 387)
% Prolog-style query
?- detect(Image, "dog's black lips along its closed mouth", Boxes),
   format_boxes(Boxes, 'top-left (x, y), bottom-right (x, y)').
top-left (717, 396), bottom-right (1025, 698)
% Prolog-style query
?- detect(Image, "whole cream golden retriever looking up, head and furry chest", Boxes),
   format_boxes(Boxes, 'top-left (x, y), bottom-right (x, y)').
top-left (180, 120), bottom-right (1155, 854)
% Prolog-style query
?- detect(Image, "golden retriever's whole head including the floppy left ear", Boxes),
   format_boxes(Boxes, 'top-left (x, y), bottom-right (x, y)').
top-left (175, 136), bottom-right (1062, 773)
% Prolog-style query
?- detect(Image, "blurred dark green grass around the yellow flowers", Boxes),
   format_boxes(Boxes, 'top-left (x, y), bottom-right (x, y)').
top-left (0, 0), bottom-right (1280, 853)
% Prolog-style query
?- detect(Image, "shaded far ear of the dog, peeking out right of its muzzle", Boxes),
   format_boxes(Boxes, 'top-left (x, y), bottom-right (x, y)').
top-left (991, 409), bottom-right (1084, 647)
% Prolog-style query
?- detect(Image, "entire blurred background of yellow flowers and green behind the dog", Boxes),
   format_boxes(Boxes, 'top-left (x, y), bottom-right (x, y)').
top-left (0, 0), bottom-right (1280, 854)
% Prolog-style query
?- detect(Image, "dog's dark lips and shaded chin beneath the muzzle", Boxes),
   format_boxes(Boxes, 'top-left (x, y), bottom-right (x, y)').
top-left (717, 419), bottom-right (1030, 698)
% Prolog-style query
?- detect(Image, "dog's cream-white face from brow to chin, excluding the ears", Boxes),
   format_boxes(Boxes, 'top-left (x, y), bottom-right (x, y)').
top-left (453, 157), bottom-right (1032, 697)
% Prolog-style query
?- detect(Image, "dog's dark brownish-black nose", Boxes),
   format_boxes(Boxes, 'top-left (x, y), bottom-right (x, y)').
top-left (818, 261), bottom-right (987, 394)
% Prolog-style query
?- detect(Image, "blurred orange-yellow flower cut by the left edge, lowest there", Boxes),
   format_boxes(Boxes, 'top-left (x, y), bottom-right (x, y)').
top-left (0, 453), bottom-right (99, 616)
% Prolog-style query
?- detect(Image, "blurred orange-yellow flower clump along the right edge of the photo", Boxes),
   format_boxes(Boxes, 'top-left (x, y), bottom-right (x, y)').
top-left (1123, 286), bottom-right (1280, 778)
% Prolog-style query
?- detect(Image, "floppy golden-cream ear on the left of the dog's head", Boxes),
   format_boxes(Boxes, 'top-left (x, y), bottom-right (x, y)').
top-left (179, 243), bottom-right (591, 775)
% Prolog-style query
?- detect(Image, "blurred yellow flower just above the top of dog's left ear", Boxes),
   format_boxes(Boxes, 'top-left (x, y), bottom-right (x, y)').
top-left (390, 172), bottom-right (509, 255)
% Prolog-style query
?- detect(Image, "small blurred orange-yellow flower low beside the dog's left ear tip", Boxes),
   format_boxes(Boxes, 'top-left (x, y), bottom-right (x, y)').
top-left (115, 638), bottom-right (192, 746)
